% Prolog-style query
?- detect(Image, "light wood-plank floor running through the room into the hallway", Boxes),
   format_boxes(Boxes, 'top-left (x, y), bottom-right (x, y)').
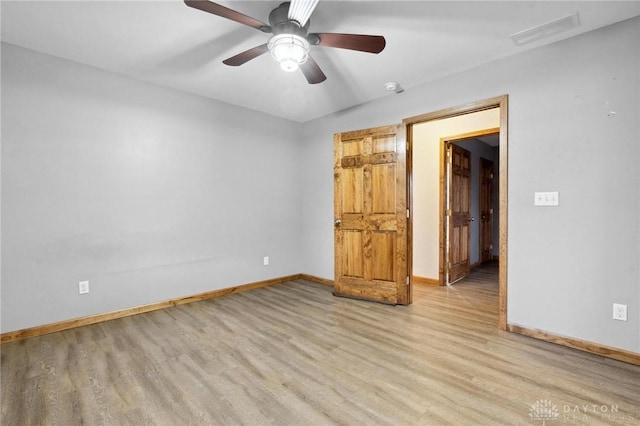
top-left (1, 267), bottom-right (640, 426)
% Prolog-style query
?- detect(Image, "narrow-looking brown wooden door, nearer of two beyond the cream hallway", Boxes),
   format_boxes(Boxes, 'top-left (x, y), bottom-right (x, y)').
top-left (447, 143), bottom-right (471, 284)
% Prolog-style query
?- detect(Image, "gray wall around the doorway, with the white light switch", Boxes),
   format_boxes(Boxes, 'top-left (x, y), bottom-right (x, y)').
top-left (302, 18), bottom-right (640, 353)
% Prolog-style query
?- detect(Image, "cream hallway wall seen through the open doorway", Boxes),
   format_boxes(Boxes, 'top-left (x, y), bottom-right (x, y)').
top-left (412, 108), bottom-right (500, 280)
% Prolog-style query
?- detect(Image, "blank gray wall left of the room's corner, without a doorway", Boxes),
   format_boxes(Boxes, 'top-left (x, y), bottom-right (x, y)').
top-left (2, 44), bottom-right (301, 332)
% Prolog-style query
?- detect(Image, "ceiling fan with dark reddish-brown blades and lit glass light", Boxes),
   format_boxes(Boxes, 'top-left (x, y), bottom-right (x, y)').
top-left (184, 0), bottom-right (386, 84)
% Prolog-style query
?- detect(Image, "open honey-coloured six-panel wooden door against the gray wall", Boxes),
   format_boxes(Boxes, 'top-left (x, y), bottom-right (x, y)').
top-left (334, 125), bottom-right (411, 304)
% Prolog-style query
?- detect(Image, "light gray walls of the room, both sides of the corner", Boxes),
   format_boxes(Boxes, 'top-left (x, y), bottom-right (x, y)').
top-left (2, 19), bottom-right (640, 353)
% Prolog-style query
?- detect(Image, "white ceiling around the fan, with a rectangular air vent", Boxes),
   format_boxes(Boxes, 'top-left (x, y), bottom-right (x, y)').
top-left (0, 0), bottom-right (640, 122)
